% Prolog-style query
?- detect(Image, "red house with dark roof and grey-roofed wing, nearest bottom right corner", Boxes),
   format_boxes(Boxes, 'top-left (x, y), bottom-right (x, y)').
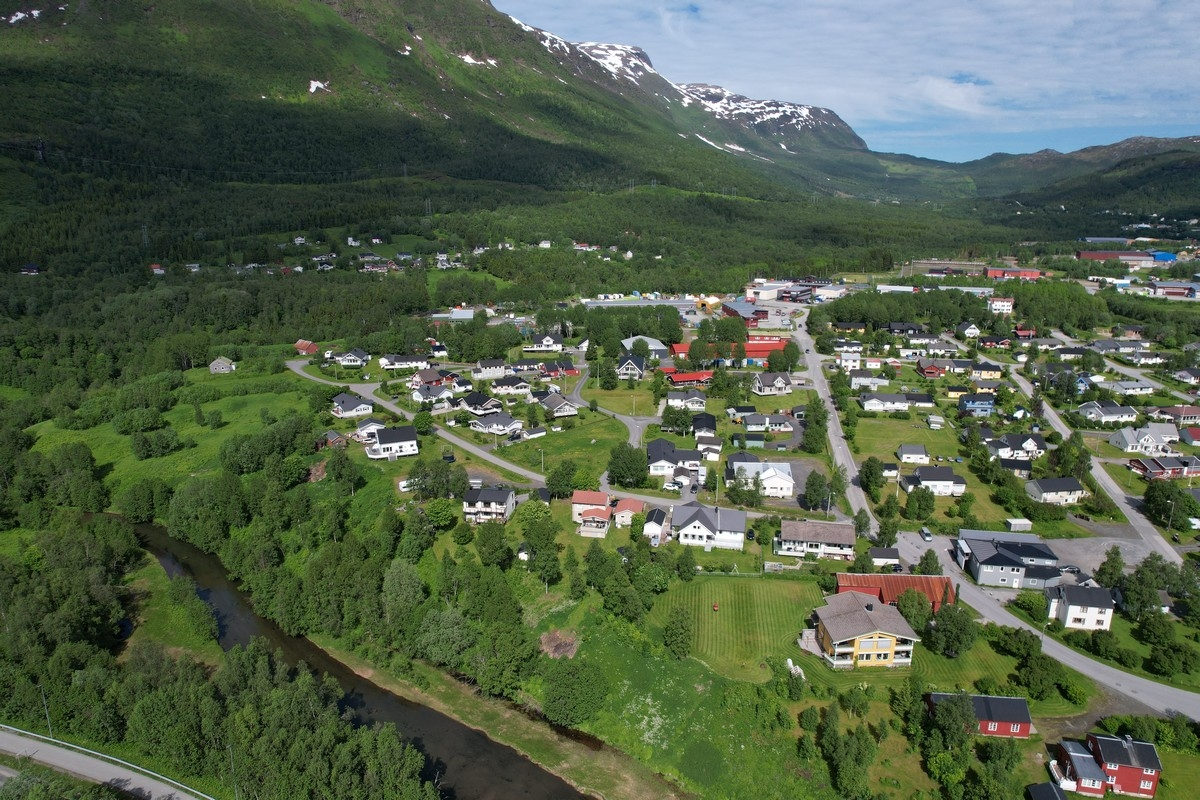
top-left (1056, 733), bottom-right (1163, 798)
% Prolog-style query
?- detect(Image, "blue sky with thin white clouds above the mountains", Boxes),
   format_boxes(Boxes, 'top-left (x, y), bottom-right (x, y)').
top-left (492, 0), bottom-right (1200, 161)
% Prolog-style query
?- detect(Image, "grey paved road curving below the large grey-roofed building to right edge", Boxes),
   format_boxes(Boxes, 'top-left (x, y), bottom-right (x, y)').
top-left (896, 534), bottom-right (1200, 718)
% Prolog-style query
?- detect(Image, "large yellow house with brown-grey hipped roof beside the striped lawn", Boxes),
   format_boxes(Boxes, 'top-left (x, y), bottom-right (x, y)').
top-left (815, 591), bottom-right (920, 669)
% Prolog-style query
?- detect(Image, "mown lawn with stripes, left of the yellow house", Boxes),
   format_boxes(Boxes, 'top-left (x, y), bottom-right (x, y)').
top-left (650, 576), bottom-right (821, 681)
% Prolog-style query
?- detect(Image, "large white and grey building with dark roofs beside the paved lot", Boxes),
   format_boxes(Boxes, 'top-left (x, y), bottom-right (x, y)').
top-left (954, 528), bottom-right (1062, 589)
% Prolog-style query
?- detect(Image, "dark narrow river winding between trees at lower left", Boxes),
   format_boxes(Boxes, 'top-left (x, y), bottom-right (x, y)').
top-left (138, 525), bottom-right (586, 800)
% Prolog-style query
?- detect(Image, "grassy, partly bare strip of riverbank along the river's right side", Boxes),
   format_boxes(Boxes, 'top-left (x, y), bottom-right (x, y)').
top-left (310, 637), bottom-right (691, 800)
